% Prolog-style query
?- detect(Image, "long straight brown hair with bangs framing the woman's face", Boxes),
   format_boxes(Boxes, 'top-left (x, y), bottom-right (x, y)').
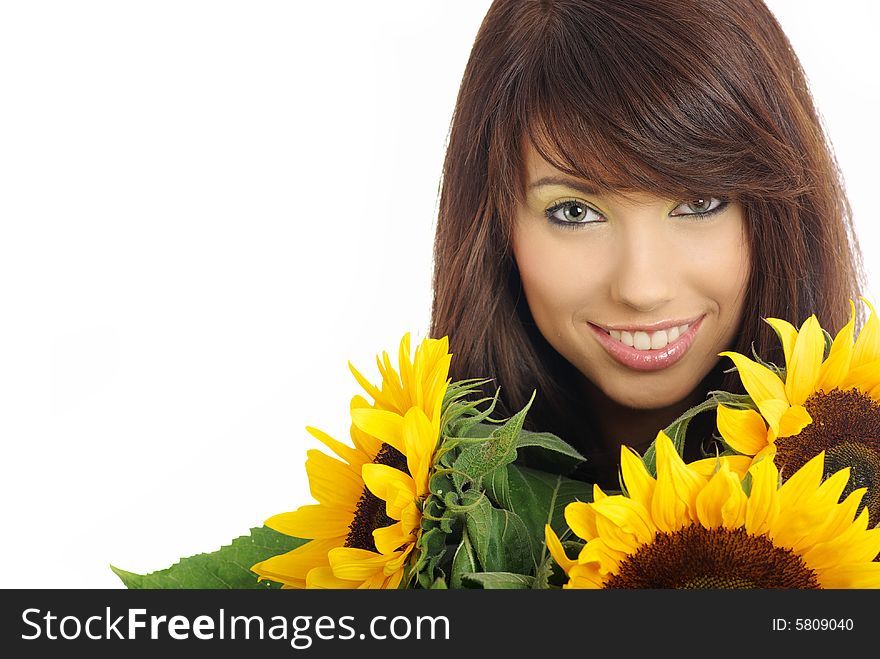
top-left (431, 0), bottom-right (862, 448)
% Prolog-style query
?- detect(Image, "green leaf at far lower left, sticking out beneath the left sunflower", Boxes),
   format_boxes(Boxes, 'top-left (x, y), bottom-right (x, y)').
top-left (110, 526), bottom-right (308, 590)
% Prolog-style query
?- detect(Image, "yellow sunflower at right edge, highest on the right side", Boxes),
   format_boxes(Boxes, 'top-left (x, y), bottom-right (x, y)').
top-left (717, 298), bottom-right (880, 526)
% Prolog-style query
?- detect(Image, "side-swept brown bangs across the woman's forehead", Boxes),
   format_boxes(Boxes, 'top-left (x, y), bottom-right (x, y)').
top-left (496, 3), bottom-right (804, 206)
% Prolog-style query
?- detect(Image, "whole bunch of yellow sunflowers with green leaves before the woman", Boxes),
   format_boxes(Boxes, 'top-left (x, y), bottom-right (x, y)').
top-left (113, 301), bottom-right (880, 589)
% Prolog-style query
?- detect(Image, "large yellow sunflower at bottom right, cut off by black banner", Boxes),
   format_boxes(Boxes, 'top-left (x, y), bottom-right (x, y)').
top-left (545, 431), bottom-right (880, 589)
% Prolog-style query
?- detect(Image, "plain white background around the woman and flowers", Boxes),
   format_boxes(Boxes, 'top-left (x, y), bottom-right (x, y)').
top-left (0, 0), bottom-right (880, 588)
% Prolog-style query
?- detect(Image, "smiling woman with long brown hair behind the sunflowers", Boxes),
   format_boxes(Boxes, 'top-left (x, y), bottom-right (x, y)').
top-left (431, 0), bottom-right (862, 488)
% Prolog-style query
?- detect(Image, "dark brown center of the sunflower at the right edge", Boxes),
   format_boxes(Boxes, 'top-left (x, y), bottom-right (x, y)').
top-left (776, 389), bottom-right (880, 526)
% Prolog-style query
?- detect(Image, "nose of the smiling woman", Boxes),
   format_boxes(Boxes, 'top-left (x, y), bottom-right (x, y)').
top-left (611, 222), bottom-right (676, 312)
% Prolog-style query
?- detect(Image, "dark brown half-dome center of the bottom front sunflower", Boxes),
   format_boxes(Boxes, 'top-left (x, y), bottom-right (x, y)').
top-left (605, 524), bottom-right (820, 590)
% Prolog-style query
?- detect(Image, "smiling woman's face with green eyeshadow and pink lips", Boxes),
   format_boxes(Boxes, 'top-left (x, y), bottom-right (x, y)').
top-left (513, 145), bottom-right (750, 409)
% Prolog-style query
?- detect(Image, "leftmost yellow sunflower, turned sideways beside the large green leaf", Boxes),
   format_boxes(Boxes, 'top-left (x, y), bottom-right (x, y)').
top-left (251, 334), bottom-right (451, 588)
